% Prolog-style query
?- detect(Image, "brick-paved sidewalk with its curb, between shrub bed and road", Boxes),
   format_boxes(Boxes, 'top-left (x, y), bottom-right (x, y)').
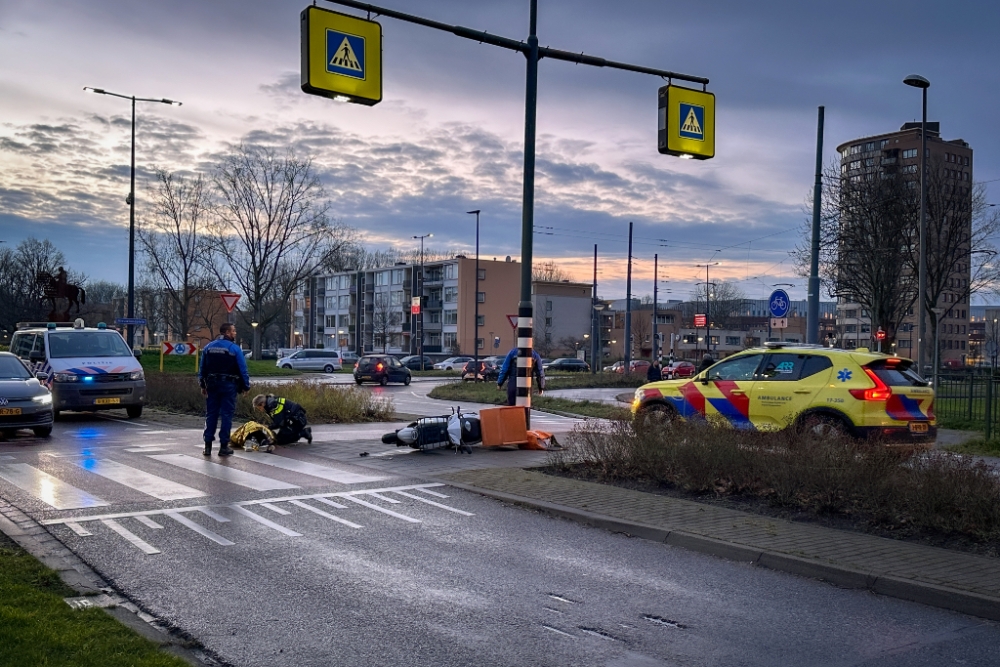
top-left (439, 468), bottom-right (1000, 620)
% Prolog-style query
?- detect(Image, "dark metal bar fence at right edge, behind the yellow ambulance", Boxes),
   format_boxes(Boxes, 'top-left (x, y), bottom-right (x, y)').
top-left (934, 370), bottom-right (1000, 440)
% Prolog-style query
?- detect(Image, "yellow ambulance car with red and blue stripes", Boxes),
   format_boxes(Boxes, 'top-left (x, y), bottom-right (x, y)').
top-left (632, 343), bottom-right (937, 449)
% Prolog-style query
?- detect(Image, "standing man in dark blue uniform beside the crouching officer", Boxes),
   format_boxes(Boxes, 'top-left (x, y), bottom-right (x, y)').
top-left (198, 322), bottom-right (250, 456)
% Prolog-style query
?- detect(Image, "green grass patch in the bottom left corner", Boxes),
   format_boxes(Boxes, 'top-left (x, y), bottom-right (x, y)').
top-left (0, 535), bottom-right (188, 667)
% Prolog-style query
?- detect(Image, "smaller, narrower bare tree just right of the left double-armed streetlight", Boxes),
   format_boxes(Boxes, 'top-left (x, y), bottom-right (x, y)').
top-left (138, 169), bottom-right (212, 340)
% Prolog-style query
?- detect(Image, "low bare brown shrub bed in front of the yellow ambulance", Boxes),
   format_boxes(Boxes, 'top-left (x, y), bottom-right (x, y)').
top-left (549, 419), bottom-right (1000, 555)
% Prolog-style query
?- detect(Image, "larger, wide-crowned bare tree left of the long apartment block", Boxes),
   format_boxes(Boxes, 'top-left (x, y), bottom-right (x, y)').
top-left (207, 144), bottom-right (354, 358)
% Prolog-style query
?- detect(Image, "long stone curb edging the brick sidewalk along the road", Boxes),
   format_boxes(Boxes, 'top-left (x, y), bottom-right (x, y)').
top-left (435, 477), bottom-right (1000, 621)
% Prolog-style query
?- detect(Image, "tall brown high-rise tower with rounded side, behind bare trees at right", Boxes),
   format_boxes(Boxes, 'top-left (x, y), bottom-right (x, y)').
top-left (837, 122), bottom-right (973, 363)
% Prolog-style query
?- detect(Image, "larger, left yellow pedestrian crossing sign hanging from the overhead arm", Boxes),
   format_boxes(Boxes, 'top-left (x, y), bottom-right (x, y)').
top-left (301, 6), bottom-right (382, 106)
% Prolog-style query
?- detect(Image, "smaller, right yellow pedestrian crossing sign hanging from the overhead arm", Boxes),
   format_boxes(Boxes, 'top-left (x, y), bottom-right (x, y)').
top-left (657, 85), bottom-right (715, 160)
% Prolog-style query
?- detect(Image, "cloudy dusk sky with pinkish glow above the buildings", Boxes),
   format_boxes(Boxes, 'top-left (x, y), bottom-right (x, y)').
top-left (0, 0), bottom-right (1000, 299)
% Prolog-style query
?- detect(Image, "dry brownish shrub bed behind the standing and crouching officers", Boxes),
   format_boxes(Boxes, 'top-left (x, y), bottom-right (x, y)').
top-left (146, 373), bottom-right (395, 424)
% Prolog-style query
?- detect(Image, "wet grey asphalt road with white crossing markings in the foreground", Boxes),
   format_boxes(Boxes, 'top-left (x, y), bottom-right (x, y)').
top-left (0, 415), bottom-right (1000, 667)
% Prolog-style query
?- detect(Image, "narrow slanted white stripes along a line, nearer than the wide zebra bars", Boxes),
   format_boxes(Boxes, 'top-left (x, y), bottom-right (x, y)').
top-left (41, 482), bottom-right (475, 556)
